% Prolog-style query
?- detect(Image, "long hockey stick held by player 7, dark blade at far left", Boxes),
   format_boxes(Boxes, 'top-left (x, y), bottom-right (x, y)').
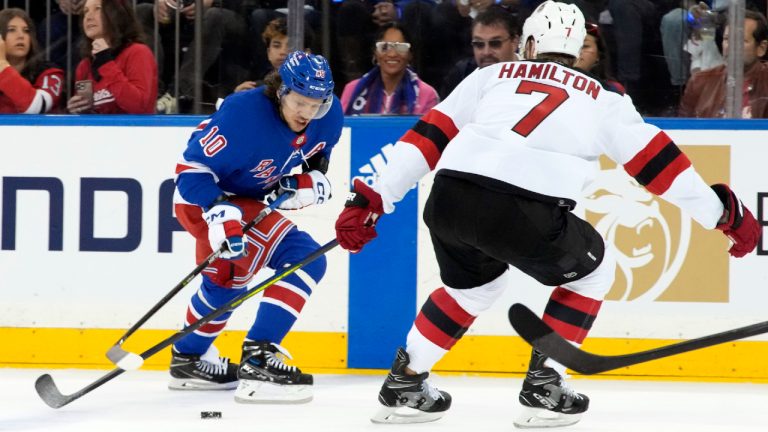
top-left (35, 239), bottom-right (339, 408)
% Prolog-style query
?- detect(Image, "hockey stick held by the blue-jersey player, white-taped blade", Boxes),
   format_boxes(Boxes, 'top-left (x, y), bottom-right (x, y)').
top-left (107, 193), bottom-right (291, 370)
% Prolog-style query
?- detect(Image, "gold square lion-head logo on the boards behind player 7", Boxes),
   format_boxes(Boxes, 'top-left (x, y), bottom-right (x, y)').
top-left (581, 146), bottom-right (730, 302)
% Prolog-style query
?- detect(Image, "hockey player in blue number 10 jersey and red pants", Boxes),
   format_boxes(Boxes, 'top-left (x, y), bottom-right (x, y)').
top-left (169, 51), bottom-right (343, 403)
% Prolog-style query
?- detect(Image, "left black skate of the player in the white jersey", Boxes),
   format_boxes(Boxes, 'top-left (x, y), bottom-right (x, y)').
top-left (371, 348), bottom-right (451, 423)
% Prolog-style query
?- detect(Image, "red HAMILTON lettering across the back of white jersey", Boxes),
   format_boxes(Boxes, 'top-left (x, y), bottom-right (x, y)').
top-left (498, 62), bottom-right (602, 99)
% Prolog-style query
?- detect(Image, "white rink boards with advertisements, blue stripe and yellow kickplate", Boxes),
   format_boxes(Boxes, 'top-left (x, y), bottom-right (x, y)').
top-left (0, 116), bottom-right (768, 380)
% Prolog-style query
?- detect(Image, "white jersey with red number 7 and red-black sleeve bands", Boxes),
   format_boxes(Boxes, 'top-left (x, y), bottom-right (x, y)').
top-left (375, 61), bottom-right (723, 229)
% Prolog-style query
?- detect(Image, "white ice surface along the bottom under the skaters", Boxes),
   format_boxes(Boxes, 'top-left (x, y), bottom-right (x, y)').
top-left (0, 369), bottom-right (768, 432)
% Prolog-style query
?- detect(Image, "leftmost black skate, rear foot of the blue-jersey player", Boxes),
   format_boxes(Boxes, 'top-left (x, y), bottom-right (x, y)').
top-left (168, 349), bottom-right (237, 390)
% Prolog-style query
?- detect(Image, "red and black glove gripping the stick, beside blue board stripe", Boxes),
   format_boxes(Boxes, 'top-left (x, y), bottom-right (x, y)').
top-left (336, 180), bottom-right (384, 253)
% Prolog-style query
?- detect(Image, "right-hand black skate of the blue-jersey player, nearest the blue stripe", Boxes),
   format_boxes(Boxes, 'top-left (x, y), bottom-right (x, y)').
top-left (235, 341), bottom-right (313, 403)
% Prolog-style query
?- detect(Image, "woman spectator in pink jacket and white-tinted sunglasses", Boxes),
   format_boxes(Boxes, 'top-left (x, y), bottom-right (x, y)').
top-left (341, 23), bottom-right (439, 115)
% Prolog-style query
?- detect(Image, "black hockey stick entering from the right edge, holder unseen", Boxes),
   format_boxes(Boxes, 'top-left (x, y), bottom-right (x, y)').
top-left (509, 303), bottom-right (768, 375)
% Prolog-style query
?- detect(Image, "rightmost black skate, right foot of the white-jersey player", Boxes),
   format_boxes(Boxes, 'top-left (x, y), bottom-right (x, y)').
top-left (514, 350), bottom-right (589, 428)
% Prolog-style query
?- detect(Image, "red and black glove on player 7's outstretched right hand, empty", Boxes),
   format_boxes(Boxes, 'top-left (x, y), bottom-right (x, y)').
top-left (712, 184), bottom-right (762, 258)
